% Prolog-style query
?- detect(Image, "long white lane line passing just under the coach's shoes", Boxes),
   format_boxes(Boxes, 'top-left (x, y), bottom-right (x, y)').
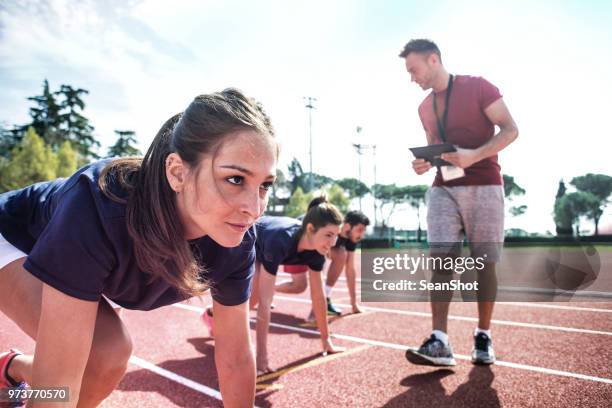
top-left (173, 303), bottom-right (612, 384)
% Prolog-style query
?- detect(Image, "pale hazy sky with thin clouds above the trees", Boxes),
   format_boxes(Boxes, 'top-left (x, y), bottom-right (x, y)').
top-left (0, 0), bottom-right (612, 232)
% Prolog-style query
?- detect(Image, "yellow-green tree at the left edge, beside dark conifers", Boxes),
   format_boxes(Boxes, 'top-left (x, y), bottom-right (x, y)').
top-left (0, 128), bottom-right (57, 191)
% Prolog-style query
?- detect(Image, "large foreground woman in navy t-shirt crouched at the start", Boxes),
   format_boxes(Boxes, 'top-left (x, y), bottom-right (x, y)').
top-left (0, 89), bottom-right (278, 407)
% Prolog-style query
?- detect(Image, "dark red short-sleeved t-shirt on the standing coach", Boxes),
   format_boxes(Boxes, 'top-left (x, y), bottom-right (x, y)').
top-left (419, 75), bottom-right (502, 187)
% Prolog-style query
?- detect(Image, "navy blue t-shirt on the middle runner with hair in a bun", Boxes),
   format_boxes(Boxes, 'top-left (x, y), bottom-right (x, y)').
top-left (255, 216), bottom-right (325, 275)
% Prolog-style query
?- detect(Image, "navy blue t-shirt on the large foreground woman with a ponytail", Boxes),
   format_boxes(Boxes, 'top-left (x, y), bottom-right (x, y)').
top-left (0, 160), bottom-right (255, 310)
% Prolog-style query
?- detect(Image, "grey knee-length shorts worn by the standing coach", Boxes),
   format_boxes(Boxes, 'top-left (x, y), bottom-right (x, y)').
top-left (426, 185), bottom-right (504, 262)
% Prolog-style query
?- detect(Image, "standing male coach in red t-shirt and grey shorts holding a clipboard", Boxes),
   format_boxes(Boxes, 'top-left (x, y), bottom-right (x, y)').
top-left (399, 39), bottom-right (518, 366)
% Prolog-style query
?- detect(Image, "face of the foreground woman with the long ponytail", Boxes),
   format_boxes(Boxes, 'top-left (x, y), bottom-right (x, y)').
top-left (166, 130), bottom-right (276, 247)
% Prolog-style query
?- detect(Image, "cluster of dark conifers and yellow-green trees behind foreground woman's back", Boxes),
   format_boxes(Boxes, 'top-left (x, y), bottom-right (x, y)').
top-left (0, 80), bottom-right (141, 192)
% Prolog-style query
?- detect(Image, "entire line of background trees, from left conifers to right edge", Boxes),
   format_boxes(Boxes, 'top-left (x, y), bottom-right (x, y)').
top-left (0, 80), bottom-right (612, 236)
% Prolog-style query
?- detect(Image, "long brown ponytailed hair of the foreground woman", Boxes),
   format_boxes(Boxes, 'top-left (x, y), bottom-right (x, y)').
top-left (98, 88), bottom-right (278, 296)
